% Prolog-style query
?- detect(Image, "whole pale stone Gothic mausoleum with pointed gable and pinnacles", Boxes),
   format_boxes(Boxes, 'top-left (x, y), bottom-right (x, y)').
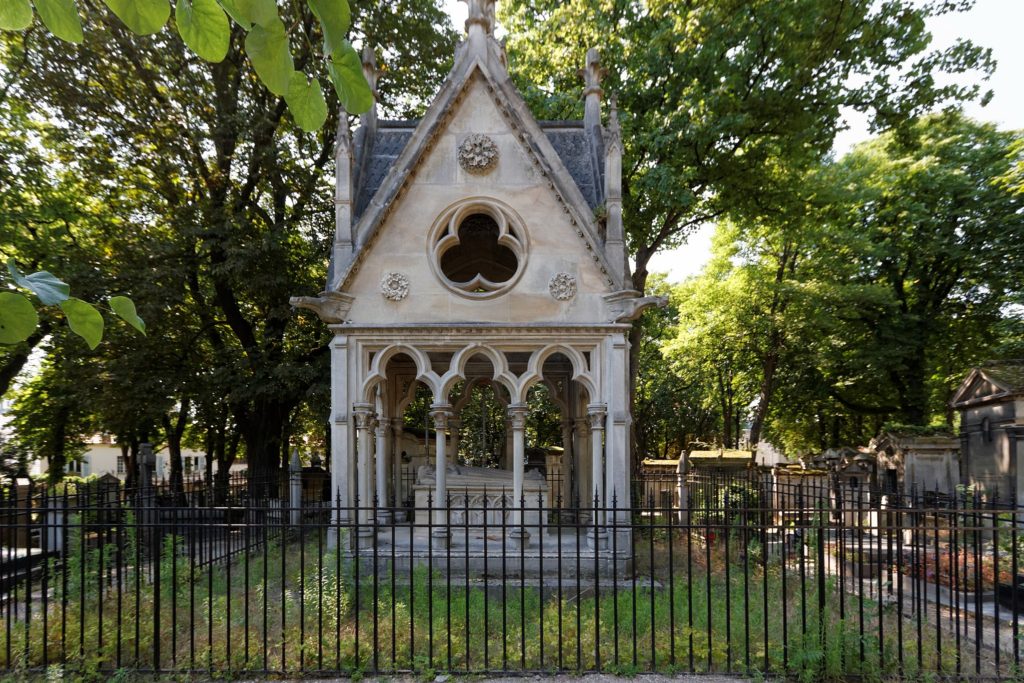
top-left (293, 0), bottom-right (659, 552)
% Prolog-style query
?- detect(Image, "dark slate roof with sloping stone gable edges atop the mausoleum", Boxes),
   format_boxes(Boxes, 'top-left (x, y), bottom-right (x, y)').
top-left (332, 30), bottom-right (626, 292)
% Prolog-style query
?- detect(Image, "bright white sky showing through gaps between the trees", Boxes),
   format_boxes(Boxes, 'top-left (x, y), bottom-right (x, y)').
top-left (444, 0), bottom-right (1024, 282)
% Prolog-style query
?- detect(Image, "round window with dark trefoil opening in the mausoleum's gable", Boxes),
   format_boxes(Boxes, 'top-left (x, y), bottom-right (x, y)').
top-left (429, 194), bottom-right (526, 299)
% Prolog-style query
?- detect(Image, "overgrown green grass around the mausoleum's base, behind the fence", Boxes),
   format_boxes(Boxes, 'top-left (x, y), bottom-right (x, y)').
top-left (0, 539), bottom-right (987, 681)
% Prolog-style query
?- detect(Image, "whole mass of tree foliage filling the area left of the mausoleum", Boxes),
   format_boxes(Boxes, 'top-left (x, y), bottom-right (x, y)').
top-left (0, 0), bottom-right (455, 481)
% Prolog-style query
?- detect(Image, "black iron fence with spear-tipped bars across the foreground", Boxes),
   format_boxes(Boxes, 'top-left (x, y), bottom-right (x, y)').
top-left (0, 476), bottom-right (1024, 680)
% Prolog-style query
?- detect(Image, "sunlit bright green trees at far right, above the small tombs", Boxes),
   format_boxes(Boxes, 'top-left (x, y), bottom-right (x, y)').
top-left (665, 114), bottom-right (1024, 455)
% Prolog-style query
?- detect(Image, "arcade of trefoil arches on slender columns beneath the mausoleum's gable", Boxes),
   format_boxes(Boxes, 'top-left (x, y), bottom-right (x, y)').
top-left (333, 330), bottom-right (629, 545)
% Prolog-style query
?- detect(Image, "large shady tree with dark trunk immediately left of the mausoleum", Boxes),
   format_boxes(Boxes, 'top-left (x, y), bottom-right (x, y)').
top-left (0, 0), bottom-right (454, 480)
